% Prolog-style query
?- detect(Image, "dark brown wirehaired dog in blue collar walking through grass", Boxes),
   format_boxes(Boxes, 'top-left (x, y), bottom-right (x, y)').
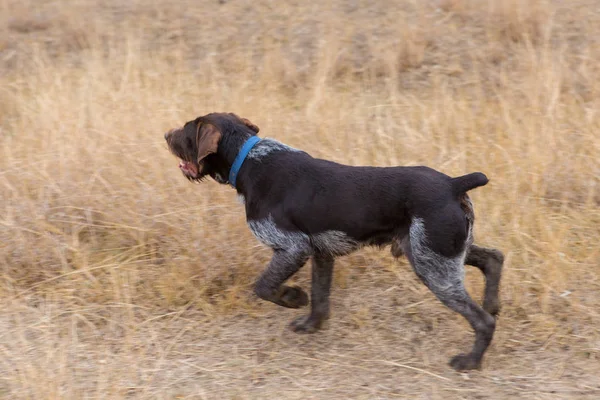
top-left (164, 113), bottom-right (504, 371)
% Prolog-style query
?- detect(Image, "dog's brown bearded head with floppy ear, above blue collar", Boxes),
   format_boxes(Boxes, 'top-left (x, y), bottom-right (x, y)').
top-left (165, 113), bottom-right (259, 183)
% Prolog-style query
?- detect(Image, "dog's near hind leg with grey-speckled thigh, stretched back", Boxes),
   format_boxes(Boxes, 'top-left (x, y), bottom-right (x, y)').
top-left (405, 219), bottom-right (496, 370)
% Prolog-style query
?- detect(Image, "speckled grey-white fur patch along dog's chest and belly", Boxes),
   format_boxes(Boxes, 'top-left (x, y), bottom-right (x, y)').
top-left (248, 215), bottom-right (359, 255)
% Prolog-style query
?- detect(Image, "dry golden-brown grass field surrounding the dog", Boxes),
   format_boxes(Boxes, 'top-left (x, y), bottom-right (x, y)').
top-left (0, 0), bottom-right (600, 400)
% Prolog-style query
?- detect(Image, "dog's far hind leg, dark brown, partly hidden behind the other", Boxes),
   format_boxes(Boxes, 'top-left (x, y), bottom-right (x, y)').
top-left (465, 244), bottom-right (504, 315)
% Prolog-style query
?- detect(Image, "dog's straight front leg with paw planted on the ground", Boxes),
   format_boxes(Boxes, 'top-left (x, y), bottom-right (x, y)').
top-left (290, 254), bottom-right (334, 333)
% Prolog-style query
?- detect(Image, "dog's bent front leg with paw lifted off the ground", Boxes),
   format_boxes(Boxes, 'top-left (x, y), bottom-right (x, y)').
top-left (254, 248), bottom-right (309, 308)
